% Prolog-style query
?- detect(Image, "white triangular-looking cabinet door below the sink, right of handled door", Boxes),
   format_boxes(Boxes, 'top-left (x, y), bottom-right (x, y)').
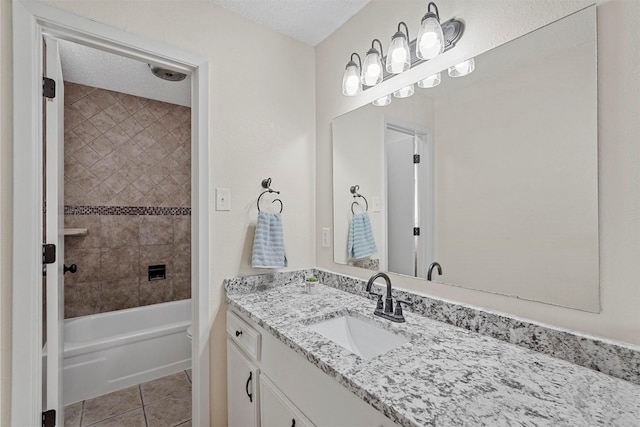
top-left (260, 374), bottom-right (313, 427)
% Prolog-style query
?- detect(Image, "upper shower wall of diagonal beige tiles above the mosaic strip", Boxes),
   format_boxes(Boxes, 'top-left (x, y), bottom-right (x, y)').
top-left (64, 82), bottom-right (191, 207)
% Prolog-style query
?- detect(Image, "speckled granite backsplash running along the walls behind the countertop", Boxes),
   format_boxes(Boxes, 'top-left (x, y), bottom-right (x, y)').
top-left (225, 269), bottom-right (640, 384)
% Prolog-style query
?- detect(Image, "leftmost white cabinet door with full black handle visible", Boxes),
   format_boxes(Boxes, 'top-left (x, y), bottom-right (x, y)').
top-left (227, 339), bottom-right (260, 427)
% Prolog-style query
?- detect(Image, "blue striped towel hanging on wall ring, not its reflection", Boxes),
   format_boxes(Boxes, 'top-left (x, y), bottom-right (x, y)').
top-left (251, 212), bottom-right (288, 268)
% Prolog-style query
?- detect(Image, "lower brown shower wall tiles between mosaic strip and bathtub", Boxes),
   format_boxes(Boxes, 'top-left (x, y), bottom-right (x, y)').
top-left (64, 215), bottom-right (191, 318)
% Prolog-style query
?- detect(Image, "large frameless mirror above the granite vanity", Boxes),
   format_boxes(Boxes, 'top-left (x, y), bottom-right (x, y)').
top-left (332, 6), bottom-right (600, 312)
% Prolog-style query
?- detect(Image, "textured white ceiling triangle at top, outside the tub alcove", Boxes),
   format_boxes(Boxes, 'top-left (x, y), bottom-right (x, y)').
top-left (212, 0), bottom-right (370, 46)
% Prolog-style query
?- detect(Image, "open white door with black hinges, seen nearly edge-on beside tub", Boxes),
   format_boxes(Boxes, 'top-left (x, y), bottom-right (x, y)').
top-left (43, 37), bottom-right (64, 426)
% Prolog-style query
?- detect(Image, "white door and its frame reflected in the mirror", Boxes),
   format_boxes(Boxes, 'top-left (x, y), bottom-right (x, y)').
top-left (385, 123), bottom-right (435, 278)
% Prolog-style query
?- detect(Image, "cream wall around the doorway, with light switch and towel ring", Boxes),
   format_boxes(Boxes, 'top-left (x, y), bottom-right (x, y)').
top-left (0, 0), bottom-right (315, 426)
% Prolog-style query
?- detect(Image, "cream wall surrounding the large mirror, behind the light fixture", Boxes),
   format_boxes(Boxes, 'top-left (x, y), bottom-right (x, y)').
top-left (316, 0), bottom-right (640, 344)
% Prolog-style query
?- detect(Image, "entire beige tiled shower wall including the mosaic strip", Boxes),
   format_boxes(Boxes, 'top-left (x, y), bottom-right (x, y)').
top-left (65, 83), bottom-right (191, 318)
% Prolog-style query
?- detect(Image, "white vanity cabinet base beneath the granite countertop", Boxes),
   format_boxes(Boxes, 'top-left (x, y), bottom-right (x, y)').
top-left (227, 309), bottom-right (396, 427)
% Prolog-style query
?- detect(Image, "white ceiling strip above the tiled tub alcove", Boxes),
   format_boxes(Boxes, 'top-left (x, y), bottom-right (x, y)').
top-left (59, 40), bottom-right (191, 106)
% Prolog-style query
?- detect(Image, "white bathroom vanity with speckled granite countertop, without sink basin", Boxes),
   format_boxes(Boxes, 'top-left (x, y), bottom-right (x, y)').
top-left (226, 273), bottom-right (640, 426)
